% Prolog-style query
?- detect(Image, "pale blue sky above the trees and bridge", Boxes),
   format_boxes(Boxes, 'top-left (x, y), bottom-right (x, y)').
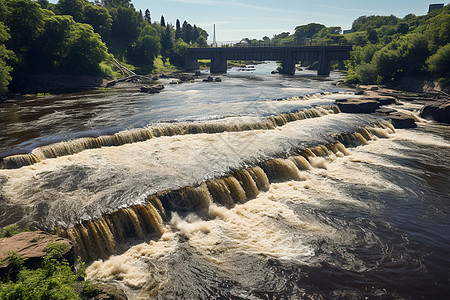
top-left (131, 0), bottom-right (442, 42)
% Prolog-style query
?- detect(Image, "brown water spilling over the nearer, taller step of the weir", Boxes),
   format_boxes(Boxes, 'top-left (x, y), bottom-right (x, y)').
top-left (64, 121), bottom-right (394, 261)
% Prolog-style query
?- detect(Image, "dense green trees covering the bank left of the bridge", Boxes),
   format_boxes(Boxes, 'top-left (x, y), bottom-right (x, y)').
top-left (0, 0), bottom-right (208, 95)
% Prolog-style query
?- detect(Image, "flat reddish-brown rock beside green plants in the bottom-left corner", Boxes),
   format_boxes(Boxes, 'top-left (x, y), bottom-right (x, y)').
top-left (0, 231), bottom-right (74, 277)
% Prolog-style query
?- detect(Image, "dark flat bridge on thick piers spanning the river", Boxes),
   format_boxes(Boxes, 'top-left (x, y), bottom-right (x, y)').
top-left (185, 46), bottom-right (352, 76)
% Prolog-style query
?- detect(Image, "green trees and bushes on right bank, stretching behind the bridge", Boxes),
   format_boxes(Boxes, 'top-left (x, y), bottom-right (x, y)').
top-left (240, 5), bottom-right (450, 84)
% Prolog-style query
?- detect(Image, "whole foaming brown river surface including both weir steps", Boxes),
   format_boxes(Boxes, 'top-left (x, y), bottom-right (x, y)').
top-left (0, 64), bottom-right (450, 299)
